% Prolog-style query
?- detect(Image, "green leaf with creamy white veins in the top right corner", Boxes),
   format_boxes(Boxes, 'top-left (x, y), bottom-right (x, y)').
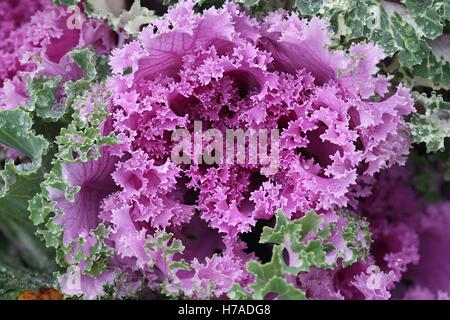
top-left (295, 0), bottom-right (450, 89)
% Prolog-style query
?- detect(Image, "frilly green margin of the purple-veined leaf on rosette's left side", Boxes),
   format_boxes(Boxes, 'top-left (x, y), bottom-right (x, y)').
top-left (28, 85), bottom-right (117, 275)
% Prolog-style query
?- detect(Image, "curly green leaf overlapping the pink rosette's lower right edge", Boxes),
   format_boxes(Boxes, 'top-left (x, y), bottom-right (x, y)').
top-left (234, 211), bottom-right (371, 300)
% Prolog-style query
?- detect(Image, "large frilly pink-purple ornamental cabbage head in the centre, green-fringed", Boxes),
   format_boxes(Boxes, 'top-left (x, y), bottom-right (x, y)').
top-left (30, 1), bottom-right (413, 299)
